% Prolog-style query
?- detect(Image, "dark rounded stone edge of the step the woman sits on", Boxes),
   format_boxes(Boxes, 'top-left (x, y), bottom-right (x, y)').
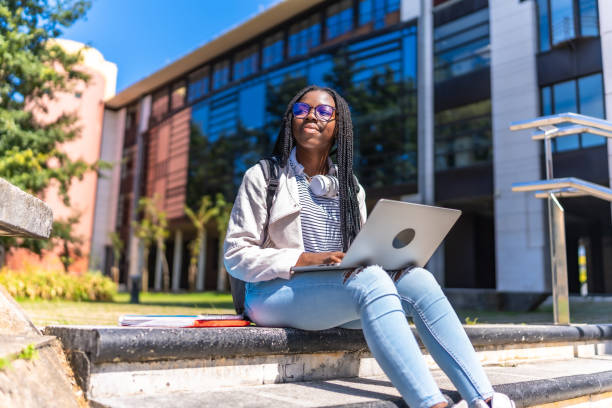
top-left (44, 325), bottom-right (612, 364)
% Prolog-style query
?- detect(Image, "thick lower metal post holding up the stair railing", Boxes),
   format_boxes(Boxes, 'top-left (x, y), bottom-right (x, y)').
top-left (548, 193), bottom-right (570, 324)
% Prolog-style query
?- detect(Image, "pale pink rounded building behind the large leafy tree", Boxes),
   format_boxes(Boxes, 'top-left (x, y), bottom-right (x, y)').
top-left (7, 39), bottom-right (117, 273)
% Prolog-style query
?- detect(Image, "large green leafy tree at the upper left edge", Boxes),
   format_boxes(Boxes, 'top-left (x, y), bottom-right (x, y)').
top-left (0, 0), bottom-right (104, 262)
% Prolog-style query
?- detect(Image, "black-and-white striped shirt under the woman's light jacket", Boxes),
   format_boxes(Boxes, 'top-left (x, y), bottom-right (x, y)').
top-left (289, 149), bottom-right (342, 252)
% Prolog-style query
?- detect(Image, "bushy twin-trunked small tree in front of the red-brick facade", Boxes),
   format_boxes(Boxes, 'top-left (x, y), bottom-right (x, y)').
top-left (132, 196), bottom-right (170, 292)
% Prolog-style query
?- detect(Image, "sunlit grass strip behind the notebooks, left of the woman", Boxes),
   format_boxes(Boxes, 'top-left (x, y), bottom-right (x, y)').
top-left (17, 292), bottom-right (235, 327)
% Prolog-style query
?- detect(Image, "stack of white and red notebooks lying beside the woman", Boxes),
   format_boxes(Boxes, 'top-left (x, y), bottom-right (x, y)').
top-left (119, 314), bottom-right (251, 327)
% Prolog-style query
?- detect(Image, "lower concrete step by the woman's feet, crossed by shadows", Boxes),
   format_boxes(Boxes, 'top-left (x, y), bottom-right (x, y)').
top-left (90, 356), bottom-right (612, 408)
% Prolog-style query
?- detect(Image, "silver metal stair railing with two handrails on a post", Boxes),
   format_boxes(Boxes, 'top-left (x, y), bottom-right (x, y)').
top-left (510, 113), bottom-right (612, 324)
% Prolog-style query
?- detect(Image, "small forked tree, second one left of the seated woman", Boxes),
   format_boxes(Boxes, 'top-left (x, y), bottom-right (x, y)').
top-left (185, 194), bottom-right (222, 291)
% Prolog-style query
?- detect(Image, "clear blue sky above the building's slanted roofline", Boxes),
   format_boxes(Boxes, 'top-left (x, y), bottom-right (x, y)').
top-left (61, 0), bottom-right (278, 92)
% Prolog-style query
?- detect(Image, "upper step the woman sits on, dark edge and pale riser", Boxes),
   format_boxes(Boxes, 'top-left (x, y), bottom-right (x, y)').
top-left (45, 325), bottom-right (612, 401)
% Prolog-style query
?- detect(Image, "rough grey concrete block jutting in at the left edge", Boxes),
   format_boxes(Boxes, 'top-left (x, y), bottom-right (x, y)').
top-left (0, 178), bottom-right (53, 239)
